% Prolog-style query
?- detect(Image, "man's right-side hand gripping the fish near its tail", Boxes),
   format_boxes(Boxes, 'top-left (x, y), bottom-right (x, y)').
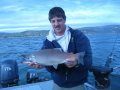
top-left (65, 53), bottom-right (77, 68)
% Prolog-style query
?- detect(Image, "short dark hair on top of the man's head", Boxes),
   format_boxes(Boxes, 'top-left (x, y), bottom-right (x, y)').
top-left (48, 7), bottom-right (66, 21)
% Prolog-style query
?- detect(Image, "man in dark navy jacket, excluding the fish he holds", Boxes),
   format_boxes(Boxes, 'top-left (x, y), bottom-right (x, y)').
top-left (28, 7), bottom-right (92, 90)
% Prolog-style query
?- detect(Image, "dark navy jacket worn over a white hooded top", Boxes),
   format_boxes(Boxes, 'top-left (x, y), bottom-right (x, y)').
top-left (42, 28), bottom-right (92, 88)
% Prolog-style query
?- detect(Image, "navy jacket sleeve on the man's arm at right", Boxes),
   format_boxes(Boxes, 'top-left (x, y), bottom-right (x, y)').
top-left (76, 32), bottom-right (92, 68)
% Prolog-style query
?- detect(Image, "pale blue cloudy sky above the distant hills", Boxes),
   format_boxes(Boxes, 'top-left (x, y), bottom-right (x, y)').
top-left (0, 0), bottom-right (120, 32)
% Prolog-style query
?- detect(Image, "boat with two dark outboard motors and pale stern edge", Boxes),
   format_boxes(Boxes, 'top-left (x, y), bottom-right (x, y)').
top-left (0, 60), bottom-right (120, 90)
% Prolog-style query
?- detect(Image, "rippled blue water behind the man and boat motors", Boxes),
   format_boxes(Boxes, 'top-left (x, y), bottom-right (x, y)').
top-left (0, 33), bottom-right (120, 84)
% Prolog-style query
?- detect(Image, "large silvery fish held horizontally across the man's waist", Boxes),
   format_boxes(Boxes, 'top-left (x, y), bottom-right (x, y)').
top-left (23, 48), bottom-right (84, 66)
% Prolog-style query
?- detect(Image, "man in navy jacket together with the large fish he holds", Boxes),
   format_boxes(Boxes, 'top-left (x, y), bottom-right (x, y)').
top-left (24, 7), bottom-right (92, 90)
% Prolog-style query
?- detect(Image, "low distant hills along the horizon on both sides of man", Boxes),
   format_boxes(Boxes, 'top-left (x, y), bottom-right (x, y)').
top-left (0, 25), bottom-right (120, 38)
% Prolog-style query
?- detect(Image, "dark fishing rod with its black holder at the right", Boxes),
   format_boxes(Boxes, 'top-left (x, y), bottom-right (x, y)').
top-left (91, 27), bottom-right (120, 90)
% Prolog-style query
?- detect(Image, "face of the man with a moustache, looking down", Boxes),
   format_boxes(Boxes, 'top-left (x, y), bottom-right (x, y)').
top-left (50, 17), bottom-right (65, 35)
